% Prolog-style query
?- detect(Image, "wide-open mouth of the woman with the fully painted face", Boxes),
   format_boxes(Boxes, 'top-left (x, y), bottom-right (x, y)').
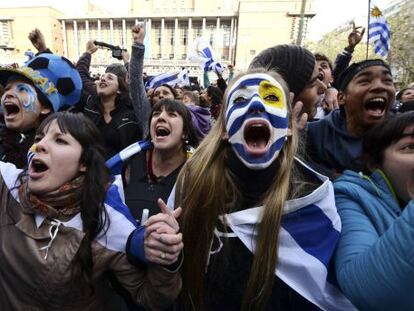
top-left (243, 120), bottom-right (270, 155)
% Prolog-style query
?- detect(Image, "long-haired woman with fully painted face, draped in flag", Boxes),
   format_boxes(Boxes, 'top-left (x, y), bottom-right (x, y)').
top-left (169, 71), bottom-right (352, 310)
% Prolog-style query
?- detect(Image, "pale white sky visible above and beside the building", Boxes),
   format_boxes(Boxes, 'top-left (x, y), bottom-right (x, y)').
top-left (0, 0), bottom-right (395, 40)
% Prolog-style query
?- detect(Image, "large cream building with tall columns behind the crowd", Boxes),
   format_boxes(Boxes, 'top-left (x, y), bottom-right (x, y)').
top-left (0, 0), bottom-right (315, 82)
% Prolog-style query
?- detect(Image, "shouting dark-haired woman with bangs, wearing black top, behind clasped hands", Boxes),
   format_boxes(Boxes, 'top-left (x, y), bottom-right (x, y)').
top-left (124, 99), bottom-right (198, 229)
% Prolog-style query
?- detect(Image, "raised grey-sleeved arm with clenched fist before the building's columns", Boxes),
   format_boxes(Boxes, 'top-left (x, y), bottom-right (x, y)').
top-left (129, 22), bottom-right (151, 137)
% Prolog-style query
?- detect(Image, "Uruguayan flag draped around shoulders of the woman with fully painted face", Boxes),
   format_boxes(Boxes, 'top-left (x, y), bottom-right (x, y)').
top-left (168, 159), bottom-right (356, 311)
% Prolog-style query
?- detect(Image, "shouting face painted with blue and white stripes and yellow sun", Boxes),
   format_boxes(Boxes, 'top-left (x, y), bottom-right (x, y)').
top-left (226, 73), bottom-right (289, 170)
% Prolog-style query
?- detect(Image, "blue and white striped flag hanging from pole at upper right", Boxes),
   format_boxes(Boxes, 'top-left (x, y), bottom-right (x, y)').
top-left (368, 7), bottom-right (391, 57)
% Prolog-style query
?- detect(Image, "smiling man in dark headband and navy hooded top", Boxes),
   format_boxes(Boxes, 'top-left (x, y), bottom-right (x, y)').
top-left (306, 59), bottom-right (395, 179)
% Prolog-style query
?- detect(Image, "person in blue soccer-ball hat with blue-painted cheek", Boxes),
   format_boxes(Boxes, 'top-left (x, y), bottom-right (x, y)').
top-left (0, 54), bottom-right (82, 168)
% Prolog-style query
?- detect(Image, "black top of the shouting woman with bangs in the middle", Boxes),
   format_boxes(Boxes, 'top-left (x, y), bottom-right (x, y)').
top-left (124, 152), bottom-right (182, 224)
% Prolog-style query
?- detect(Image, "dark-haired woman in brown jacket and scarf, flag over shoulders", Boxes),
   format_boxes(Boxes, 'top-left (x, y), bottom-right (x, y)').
top-left (0, 112), bottom-right (181, 310)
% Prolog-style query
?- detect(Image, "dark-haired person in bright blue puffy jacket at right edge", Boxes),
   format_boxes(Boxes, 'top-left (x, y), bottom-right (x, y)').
top-left (335, 112), bottom-right (414, 310)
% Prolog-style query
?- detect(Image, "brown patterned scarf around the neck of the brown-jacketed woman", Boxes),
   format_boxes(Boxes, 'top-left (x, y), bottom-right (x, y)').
top-left (19, 175), bottom-right (85, 219)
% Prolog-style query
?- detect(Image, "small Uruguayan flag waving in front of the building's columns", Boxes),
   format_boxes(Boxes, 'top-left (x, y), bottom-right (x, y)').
top-left (188, 37), bottom-right (223, 74)
